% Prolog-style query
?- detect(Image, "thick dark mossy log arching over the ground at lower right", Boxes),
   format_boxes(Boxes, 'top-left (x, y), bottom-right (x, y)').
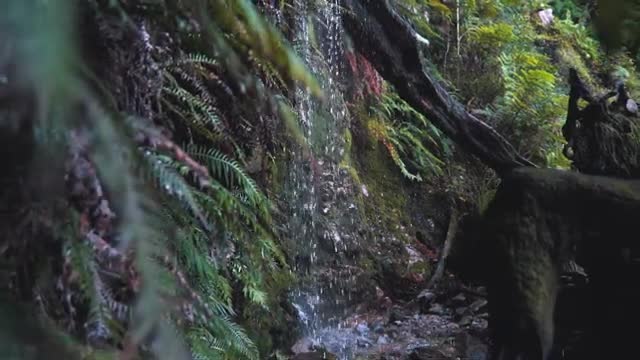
top-left (481, 168), bottom-right (640, 359)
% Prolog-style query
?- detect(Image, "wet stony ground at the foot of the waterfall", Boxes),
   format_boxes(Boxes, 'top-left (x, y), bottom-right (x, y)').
top-left (291, 284), bottom-right (488, 360)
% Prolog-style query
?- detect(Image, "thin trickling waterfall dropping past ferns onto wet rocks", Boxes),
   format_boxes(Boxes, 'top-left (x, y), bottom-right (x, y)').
top-left (285, 0), bottom-right (364, 358)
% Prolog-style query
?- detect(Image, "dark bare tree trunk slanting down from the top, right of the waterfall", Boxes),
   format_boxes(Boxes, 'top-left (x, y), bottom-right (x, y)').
top-left (342, 0), bottom-right (535, 174)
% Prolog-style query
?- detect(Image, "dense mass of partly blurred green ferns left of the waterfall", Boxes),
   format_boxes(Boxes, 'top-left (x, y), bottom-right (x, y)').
top-left (0, 0), bottom-right (312, 360)
